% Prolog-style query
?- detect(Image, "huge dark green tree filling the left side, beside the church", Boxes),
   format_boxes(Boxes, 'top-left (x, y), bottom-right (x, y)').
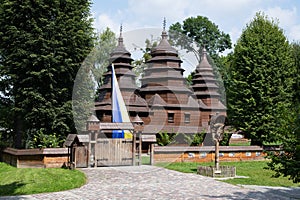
top-left (0, 0), bottom-right (93, 148)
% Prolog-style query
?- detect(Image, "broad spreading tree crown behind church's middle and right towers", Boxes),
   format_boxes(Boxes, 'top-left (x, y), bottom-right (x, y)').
top-left (169, 16), bottom-right (231, 61)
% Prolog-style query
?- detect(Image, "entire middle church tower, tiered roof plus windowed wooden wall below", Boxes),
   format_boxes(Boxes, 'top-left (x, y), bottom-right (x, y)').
top-left (140, 22), bottom-right (200, 134)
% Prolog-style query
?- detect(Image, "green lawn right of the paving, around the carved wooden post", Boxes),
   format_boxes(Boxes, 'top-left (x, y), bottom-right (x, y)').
top-left (157, 161), bottom-right (300, 187)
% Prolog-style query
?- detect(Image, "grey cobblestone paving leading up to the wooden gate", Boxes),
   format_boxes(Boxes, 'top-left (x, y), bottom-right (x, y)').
top-left (0, 166), bottom-right (300, 200)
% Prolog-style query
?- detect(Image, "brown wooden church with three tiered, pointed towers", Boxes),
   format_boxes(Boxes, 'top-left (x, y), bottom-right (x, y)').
top-left (95, 22), bottom-right (226, 147)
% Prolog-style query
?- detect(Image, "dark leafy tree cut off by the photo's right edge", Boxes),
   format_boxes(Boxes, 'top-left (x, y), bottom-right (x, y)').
top-left (268, 43), bottom-right (300, 182)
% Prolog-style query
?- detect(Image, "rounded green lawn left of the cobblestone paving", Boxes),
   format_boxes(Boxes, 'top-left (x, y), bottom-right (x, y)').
top-left (0, 162), bottom-right (86, 196)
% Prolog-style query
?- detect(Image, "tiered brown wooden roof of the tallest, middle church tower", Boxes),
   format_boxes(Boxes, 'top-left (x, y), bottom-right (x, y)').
top-left (140, 23), bottom-right (192, 105)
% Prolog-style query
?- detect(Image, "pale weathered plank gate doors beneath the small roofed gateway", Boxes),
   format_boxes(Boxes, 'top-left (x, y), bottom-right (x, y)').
top-left (95, 138), bottom-right (133, 167)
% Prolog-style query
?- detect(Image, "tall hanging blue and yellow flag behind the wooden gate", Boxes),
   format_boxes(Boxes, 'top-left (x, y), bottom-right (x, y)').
top-left (111, 64), bottom-right (132, 138)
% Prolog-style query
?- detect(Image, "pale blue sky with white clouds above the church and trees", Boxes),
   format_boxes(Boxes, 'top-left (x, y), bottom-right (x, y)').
top-left (92, 0), bottom-right (300, 43)
